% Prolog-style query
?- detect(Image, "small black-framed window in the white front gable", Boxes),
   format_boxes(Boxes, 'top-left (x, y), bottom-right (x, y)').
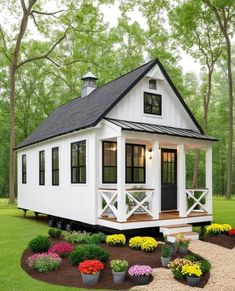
top-left (144, 92), bottom-right (162, 115)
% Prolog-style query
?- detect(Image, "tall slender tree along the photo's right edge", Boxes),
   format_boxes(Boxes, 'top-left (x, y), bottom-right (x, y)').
top-left (203, 0), bottom-right (235, 199)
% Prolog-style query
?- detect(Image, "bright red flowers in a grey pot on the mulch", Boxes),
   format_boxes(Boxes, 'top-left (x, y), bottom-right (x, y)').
top-left (78, 260), bottom-right (104, 284)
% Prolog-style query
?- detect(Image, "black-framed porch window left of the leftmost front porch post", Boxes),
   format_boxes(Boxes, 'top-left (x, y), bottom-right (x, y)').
top-left (102, 141), bottom-right (117, 183)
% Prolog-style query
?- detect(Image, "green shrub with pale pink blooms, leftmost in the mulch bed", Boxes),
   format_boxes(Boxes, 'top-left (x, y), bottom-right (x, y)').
top-left (28, 253), bottom-right (61, 273)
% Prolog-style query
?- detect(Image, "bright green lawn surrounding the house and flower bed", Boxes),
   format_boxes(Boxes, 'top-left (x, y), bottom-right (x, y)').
top-left (0, 197), bottom-right (235, 291)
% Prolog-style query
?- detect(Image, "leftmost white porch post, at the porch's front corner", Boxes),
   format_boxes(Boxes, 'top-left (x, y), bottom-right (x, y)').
top-left (117, 136), bottom-right (126, 222)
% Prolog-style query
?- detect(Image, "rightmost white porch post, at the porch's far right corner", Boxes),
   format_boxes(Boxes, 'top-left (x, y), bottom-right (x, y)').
top-left (206, 147), bottom-right (212, 214)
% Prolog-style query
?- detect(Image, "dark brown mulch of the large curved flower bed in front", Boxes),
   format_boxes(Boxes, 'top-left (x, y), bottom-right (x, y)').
top-left (21, 239), bottom-right (210, 290)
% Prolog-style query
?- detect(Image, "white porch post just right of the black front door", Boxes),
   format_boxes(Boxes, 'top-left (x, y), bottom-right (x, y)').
top-left (177, 144), bottom-right (187, 217)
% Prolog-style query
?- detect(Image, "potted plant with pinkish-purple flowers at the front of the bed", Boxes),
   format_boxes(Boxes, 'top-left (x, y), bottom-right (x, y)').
top-left (128, 265), bottom-right (152, 285)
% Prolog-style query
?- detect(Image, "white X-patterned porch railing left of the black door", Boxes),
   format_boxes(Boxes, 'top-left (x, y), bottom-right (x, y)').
top-left (98, 188), bottom-right (154, 220)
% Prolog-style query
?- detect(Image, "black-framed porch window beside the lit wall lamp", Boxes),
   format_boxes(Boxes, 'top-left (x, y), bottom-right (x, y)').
top-left (126, 144), bottom-right (145, 183)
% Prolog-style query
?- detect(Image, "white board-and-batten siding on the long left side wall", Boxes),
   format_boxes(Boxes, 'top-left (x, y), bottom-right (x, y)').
top-left (18, 129), bottom-right (97, 224)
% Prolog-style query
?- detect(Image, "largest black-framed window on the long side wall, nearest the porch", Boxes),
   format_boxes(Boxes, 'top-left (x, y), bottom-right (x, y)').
top-left (71, 140), bottom-right (86, 183)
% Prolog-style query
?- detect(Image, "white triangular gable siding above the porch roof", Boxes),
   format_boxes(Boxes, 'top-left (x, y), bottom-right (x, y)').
top-left (107, 65), bottom-right (198, 132)
